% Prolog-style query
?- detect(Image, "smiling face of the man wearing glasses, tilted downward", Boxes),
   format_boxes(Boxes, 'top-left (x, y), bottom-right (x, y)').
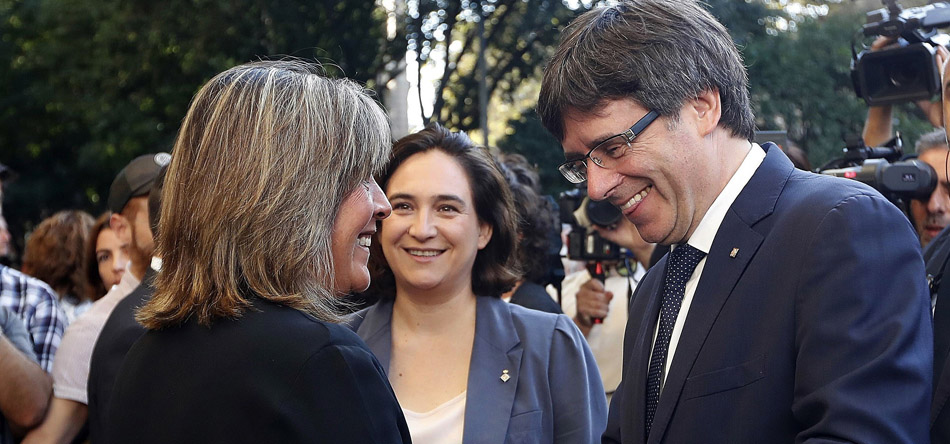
top-left (561, 99), bottom-right (721, 245)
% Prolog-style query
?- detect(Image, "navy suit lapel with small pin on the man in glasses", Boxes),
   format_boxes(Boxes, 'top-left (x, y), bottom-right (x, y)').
top-left (641, 144), bottom-right (793, 443)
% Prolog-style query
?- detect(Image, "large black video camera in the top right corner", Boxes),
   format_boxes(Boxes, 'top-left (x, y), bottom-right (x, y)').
top-left (851, 0), bottom-right (950, 106)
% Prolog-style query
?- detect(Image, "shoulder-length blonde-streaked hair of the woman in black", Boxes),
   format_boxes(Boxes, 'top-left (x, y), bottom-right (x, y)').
top-left (137, 60), bottom-right (392, 329)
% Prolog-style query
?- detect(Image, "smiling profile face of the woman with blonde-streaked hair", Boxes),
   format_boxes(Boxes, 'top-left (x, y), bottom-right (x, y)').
top-left (331, 178), bottom-right (392, 294)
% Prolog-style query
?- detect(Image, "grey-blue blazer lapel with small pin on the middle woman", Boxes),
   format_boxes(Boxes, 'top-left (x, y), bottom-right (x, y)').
top-left (462, 296), bottom-right (523, 443)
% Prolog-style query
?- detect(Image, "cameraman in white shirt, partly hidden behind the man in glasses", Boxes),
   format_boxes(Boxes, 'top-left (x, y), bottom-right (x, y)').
top-left (561, 217), bottom-right (654, 400)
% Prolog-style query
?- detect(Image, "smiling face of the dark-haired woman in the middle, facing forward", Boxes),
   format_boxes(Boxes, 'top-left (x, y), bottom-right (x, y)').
top-left (379, 149), bottom-right (492, 295)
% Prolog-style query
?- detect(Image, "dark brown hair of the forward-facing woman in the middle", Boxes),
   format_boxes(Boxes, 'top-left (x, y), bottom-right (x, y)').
top-left (370, 123), bottom-right (520, 298)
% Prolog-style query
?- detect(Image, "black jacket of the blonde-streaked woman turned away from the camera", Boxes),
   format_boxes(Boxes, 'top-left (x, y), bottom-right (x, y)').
top-left (106, 298), bottom-right (410, 444)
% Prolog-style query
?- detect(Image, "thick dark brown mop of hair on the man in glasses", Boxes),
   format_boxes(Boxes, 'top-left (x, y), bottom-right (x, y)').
top-left (537, 0), bottom-right (755, 140)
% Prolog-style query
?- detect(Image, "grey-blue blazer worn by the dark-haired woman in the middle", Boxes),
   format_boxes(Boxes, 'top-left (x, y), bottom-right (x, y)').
top-left (348, 296), bottom-right (607, 444)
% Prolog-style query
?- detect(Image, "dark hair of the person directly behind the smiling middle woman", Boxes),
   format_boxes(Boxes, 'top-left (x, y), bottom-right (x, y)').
top-left (496, 154), bottom-right (560, 284)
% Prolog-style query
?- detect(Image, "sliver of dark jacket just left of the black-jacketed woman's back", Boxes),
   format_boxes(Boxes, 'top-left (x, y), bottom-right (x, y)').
top-left (86, 267), bottom-right (157, 443)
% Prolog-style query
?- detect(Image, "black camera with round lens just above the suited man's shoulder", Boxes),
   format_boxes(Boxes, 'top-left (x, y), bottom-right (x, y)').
top-left (819, 134), bottom-right (937, 205)
